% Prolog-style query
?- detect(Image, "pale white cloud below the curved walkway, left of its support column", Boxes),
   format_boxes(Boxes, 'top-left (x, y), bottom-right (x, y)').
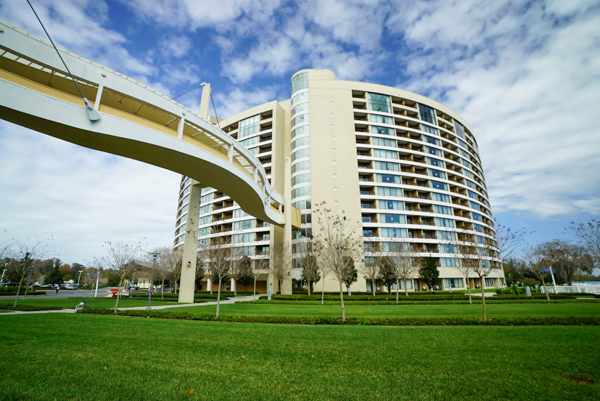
top-left (0, 122), bottom-right (180, 263)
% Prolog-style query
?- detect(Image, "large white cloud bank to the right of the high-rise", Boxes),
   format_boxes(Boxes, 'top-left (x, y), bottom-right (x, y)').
top-left (388, 1), bottom-right (600, 217)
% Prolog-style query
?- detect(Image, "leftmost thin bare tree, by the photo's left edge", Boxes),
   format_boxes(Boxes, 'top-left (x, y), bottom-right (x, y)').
top-left (3, 234), bottom-right (52, 306)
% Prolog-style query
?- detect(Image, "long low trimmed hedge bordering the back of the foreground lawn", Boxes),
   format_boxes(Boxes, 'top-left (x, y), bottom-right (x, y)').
top-left (79, 308), bottom-right (600, 326)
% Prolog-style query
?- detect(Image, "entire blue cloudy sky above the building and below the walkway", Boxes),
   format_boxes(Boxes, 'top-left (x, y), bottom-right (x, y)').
top-left (0, 0), bottom-right (600, 263)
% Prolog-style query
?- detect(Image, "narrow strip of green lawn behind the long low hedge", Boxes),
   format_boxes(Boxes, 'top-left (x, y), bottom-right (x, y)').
top-left (159, 303), bottom-right (600, 318)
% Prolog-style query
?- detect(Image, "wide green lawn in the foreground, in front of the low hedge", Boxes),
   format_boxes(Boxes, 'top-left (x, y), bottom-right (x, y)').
top-left (0, 314), bottom-right (600, 401)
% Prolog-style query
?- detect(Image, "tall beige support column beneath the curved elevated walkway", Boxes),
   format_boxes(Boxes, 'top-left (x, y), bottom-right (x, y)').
top-left (179, 180), bottom-right (201, 303)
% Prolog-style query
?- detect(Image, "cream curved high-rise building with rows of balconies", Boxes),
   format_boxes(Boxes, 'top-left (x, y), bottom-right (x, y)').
top-left (175, 70), bottom-right (504, 291)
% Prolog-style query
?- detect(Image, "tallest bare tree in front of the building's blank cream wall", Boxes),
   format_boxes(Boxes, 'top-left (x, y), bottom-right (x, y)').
top-left (313, 202), bottom-right (362, 321)
